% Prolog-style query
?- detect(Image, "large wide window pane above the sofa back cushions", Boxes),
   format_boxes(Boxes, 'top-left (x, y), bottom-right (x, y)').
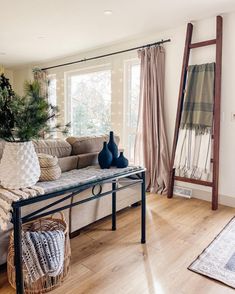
top-left (68, 67), bottom-right (111, 136)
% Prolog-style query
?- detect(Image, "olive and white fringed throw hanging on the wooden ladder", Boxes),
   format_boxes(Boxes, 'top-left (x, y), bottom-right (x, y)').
top-left (174, 63), bottom-right (215, 180)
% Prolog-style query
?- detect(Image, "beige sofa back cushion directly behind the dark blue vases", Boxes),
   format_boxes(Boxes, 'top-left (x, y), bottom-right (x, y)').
top-left (66, 135), bottom-right (119, 155)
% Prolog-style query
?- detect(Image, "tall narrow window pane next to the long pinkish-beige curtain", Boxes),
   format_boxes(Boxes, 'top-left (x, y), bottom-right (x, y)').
top-left (124, 59), bottom-right (140, 163)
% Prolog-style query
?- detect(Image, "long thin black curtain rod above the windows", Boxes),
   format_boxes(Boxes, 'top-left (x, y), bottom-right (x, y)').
top-left (41, 39), bottom-right (171, 70)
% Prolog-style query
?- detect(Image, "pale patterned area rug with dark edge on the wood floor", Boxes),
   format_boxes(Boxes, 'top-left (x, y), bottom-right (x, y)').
top-left (188, 218), bottom-right (235, 288)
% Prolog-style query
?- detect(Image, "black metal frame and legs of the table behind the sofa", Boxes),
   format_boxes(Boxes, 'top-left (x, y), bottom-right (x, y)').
top-left (12, 168), bottom-right (146, 294)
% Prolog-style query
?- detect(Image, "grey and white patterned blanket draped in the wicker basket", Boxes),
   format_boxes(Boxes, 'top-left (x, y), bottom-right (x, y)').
top-left (22, 230), bottom-right (65, 282)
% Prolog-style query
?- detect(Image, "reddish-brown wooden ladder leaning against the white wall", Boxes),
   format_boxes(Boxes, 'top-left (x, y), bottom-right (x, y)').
top-left (168, 16), bottom-right (223, 210)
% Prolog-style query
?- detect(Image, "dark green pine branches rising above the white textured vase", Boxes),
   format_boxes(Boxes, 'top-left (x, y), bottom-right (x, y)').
top-left (0, 74), bottom-right (70, 142)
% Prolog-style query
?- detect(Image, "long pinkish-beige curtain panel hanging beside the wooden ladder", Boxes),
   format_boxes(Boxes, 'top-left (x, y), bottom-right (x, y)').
top-left (135, 46), bottom-right (170, 193)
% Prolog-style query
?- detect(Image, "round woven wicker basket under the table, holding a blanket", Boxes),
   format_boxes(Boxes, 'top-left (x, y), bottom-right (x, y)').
top-left (7, 213), bottom-right (71, 294)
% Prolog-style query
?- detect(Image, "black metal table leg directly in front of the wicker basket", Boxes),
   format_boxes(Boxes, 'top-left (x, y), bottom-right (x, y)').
top-left (13, 207), bottom-right (24, 294)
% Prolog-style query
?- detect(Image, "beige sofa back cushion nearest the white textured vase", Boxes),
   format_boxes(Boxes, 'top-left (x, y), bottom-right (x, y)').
top-left (33, 139), bottom-right (72, 158)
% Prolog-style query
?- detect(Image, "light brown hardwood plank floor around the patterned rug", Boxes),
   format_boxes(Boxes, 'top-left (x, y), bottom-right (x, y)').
top-left (0, 195), bottom-right (235, 294)
